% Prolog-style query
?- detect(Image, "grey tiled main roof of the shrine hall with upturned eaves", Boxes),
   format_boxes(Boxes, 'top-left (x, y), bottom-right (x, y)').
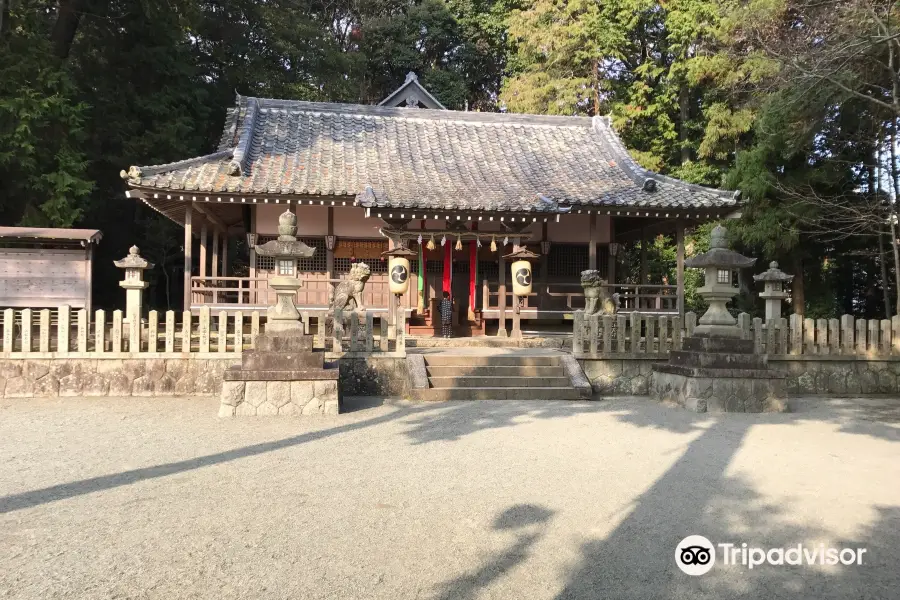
top-left (123, 97), bottom-right (738, 212)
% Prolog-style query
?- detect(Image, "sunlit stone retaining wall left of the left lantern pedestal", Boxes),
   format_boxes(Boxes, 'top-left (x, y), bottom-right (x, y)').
top-left (0, 356), bottom-right (240, 398)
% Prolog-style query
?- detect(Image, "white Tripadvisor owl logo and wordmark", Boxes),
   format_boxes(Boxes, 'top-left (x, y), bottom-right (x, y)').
top-left (675, 535), bottom-right (866, 575)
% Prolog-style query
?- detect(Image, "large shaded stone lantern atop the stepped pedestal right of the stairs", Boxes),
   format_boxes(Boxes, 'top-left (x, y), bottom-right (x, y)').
top-left (684, 225), bottom-right (756, 338)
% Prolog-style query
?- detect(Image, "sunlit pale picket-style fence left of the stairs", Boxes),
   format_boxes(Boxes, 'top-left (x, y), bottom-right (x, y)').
top-left (0, 306), bottom-right (406, 358)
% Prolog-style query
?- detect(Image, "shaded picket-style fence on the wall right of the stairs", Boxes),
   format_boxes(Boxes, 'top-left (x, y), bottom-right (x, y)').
top-left (572, 311), bottom-right (900, 358)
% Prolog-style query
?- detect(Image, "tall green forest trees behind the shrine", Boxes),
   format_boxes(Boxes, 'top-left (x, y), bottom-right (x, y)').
top-left (0, 0), bottom-right (900, 318)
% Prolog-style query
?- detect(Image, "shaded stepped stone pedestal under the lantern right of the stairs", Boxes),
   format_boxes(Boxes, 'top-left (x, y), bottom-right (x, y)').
top-left (650, 336), bottom-right (787, 412)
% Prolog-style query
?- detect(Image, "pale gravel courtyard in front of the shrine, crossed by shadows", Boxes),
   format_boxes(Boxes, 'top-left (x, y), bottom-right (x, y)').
top-left (0, 398), bottom-right (900, 600)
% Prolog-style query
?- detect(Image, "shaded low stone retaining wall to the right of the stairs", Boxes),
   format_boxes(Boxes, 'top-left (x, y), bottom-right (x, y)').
top-left (578, 354), bottom-right (900, 396)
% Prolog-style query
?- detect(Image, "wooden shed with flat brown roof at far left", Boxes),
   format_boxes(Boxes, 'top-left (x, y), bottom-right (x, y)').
top-left (0, 227), bottom-right (103, 314)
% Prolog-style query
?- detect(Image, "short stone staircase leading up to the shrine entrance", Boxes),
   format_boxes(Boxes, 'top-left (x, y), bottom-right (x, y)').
top-left (408, 352), bottom-right (591, 401)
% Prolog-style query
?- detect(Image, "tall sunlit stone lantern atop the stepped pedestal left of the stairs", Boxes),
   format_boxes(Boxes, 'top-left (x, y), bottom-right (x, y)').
top-left (256, 210), bottom-right (316, 332)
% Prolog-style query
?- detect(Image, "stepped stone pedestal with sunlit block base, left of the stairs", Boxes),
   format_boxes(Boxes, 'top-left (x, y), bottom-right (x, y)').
top-left (219, 330), bottom-right (341, 417)
